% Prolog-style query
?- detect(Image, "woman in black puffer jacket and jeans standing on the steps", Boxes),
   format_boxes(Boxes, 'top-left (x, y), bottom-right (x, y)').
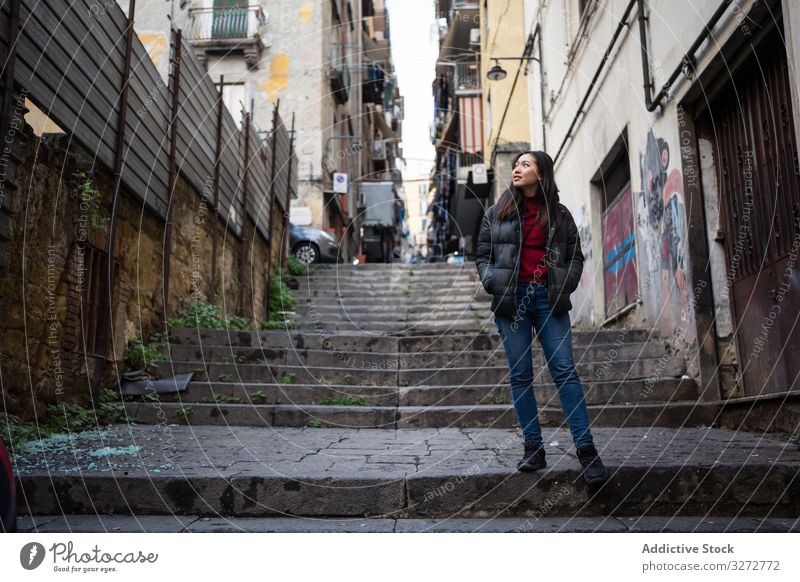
top-left (475, 151), bottom-right (606, 483)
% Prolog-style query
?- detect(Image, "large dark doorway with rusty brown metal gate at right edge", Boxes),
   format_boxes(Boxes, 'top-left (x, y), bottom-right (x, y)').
top-left (698, 29), bottom-right (800, 396)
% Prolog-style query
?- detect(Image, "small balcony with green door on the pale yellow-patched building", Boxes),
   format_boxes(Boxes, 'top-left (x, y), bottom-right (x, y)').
top-left (187, 4), bottom-right (268, 69)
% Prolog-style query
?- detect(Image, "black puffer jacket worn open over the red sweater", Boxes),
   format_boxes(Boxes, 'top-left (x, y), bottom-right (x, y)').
top-left (475, 202), bottom-right (583, 317)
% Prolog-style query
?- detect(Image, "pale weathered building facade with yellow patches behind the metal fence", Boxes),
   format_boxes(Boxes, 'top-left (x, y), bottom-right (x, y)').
top-left (119, 0), bottom-right (402, 258)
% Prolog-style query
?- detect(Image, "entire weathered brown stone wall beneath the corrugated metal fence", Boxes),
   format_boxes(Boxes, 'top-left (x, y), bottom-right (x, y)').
top-left (0, 117), bottom-right (278, 419)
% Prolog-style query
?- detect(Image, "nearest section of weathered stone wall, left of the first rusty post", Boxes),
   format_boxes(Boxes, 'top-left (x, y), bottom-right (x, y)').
top-left (0, 121), bottom-right (106, 418)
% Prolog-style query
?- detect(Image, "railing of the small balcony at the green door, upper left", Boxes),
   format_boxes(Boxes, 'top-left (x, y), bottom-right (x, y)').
top-left (189, 5), bottom-right (267, 41)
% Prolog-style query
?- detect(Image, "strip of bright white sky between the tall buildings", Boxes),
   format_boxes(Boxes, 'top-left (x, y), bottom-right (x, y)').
top-left (386, 0), bottom-right (439, 179)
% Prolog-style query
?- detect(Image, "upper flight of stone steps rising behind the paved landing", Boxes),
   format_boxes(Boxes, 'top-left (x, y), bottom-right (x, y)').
top-left (127, 264), bottom-right (716, 428)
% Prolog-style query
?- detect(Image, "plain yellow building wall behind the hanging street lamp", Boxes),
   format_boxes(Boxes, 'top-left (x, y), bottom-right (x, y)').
top-left (479, 0), bottom-right (535, 163)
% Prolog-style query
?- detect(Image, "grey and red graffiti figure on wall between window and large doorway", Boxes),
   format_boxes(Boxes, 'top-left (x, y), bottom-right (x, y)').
top-left (637, 129), bottom-right (694, 342)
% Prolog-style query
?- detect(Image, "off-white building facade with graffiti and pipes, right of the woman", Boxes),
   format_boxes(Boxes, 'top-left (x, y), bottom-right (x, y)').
top-left (525, 0), bottom-right (800, 429)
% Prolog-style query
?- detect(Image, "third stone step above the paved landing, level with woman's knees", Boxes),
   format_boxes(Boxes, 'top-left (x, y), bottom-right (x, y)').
top-left (152, 356), bottom-right (685, 386)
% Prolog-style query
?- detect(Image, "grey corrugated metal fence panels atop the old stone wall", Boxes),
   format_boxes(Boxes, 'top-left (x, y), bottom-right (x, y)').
top-left (0, 0), bottom-right (297, 240)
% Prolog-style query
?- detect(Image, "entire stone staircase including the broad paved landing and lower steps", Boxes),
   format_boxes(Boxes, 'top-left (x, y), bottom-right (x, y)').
top-left (12, 264), bottom-right (800, 531)
